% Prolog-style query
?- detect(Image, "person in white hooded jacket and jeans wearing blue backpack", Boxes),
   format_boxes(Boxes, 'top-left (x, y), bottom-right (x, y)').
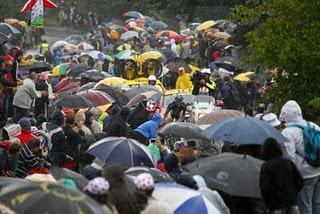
top-left (280, 100), bottom-right (320, 214)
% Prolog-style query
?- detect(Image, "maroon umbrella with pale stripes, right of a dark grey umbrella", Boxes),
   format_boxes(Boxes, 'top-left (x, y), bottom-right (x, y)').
top-left (77, 89), bottom-right (115, 106)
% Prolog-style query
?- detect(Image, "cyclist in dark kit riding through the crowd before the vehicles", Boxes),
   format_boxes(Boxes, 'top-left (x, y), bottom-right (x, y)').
top-left (164, 94), bottom-right (187, 121)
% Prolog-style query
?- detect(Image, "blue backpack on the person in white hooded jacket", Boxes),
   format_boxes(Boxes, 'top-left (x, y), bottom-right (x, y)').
top-left (288, 122), bottom-right (320, 167)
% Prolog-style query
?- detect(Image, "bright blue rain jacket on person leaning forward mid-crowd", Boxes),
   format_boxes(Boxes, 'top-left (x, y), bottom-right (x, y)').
top-left (135, 114), bottom-right (162, 140)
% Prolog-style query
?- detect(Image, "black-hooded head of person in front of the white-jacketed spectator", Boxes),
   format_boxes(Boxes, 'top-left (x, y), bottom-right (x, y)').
top-left (261, 138), bottom-right (283, 161)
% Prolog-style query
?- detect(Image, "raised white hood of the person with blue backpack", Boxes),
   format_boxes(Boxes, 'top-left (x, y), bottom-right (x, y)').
top-left (280, 100), bottom-right (303, 123)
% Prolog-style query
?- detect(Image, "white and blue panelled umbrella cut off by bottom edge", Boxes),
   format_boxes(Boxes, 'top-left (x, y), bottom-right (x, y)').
top-left (153, 183), bottom-right (221, 214)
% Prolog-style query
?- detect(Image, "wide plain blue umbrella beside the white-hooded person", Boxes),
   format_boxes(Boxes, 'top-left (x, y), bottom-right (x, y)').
top-left (202, 117), bottom-right (288, 145)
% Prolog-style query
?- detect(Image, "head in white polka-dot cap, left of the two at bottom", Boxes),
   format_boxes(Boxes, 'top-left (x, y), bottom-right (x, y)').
top-left (84, 177), bottom-right (110, 205)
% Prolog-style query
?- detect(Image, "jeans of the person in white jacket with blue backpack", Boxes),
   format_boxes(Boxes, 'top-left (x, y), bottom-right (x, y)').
top-left (298, 176), bottom-right (320, 214)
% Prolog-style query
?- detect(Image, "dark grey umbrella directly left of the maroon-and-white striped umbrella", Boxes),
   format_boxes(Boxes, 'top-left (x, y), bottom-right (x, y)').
top-left (54, 94), bottom-right (94, 109)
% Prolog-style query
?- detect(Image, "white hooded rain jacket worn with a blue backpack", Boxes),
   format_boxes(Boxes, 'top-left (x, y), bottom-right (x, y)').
top-left (280, 100), bottom-right (320, 179)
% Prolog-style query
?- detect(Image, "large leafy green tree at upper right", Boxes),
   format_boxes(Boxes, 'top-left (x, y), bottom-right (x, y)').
top-left (232, 0), bottom-right (320, 117)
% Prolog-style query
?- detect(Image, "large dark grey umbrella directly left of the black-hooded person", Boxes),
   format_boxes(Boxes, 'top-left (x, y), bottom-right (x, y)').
top-left (186, 153), bottom-right (263, 198)
